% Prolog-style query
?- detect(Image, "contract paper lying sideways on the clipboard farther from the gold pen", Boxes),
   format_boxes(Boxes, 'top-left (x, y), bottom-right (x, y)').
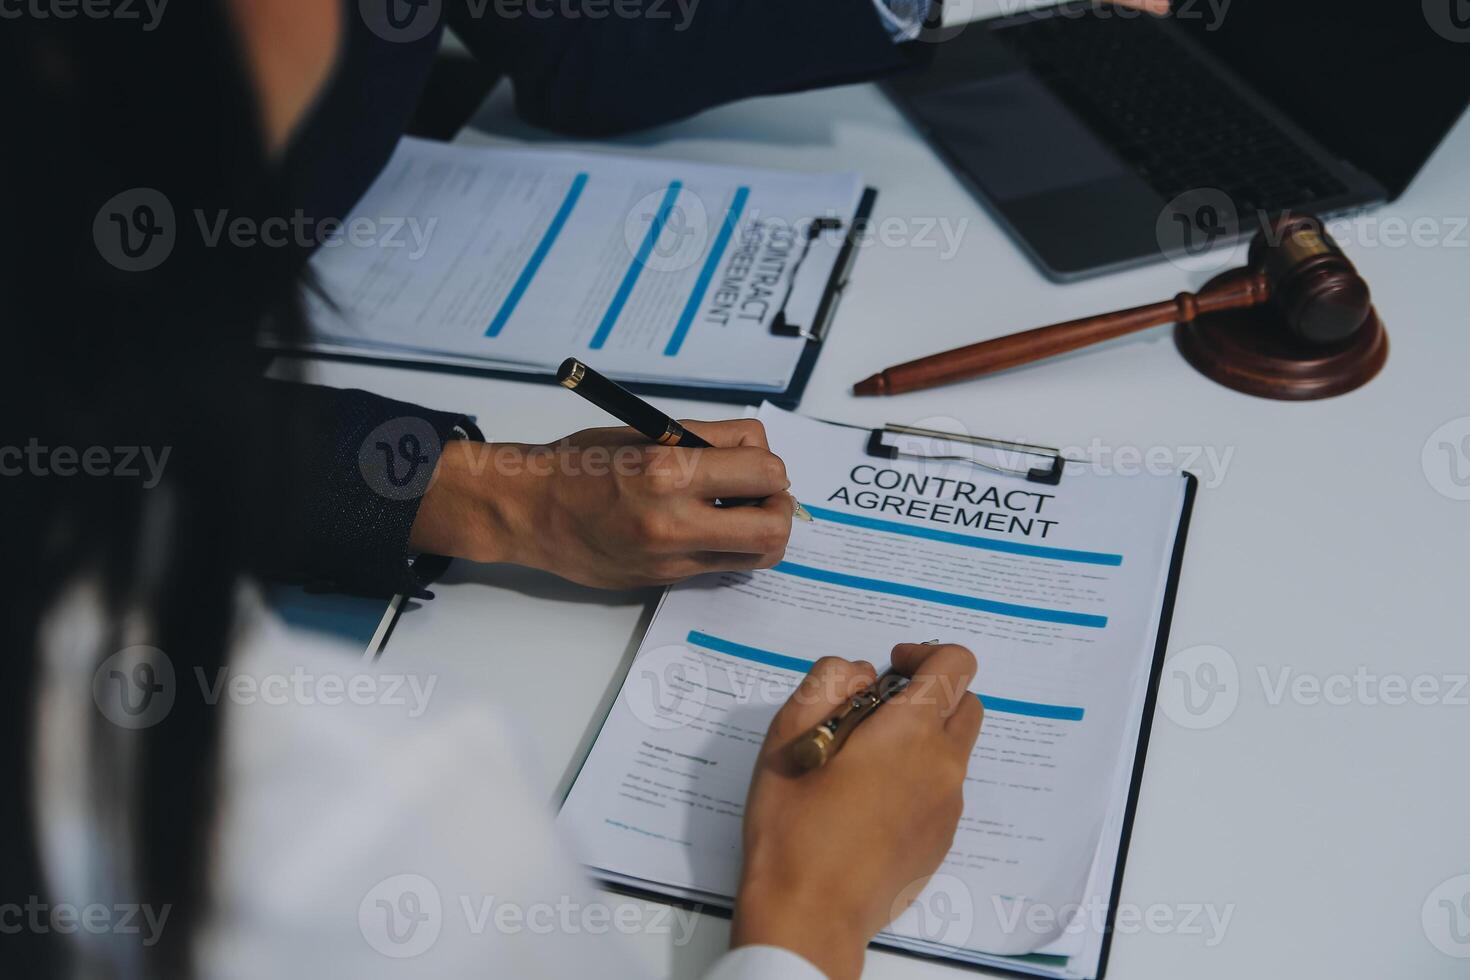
top-left (292, 138), bottom-right (863, 391)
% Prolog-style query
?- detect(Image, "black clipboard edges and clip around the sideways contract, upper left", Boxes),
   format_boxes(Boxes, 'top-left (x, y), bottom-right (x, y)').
top-left (271, 187), bottom-right (878, 408)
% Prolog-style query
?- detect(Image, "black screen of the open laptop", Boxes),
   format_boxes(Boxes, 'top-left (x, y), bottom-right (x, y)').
top-left (1175, 0), bottom-right (1470, 197)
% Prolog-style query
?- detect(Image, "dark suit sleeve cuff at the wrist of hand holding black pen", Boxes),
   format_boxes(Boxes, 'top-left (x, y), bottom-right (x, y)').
top-left (257, 381), bottom-right (479, 597)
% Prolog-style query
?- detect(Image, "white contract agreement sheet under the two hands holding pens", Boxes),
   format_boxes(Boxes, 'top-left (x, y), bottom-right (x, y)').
top-left (559, 406), bottom-right (1194, 977)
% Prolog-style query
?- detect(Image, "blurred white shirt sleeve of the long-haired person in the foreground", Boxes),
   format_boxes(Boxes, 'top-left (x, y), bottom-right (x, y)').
top-left (200, 599), bottom-right (823, 980)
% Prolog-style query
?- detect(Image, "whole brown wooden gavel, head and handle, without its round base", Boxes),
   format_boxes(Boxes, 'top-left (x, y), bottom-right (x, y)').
top-left (853, 215), bottom-right (1373, 395)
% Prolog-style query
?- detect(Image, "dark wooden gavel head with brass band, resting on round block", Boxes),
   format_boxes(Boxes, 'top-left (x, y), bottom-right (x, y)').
top-left (1250, 215), bottom-right (1373, 345)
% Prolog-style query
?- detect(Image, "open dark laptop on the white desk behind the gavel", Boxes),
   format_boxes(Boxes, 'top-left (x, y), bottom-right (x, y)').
top-left (885, 0), bottom-right (1470, 281)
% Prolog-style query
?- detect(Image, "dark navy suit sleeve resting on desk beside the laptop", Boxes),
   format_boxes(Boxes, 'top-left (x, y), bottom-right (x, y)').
top-left (445, 0), bottom-right (932, 137)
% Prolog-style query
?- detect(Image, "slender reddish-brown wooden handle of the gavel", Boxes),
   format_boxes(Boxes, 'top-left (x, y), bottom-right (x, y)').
top-left (854, 272), bottom-right (1269, 395)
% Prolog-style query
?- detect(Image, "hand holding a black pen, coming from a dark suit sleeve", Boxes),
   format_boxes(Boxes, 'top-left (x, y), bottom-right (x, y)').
top-left (410, 419), bottom-right (795, 588)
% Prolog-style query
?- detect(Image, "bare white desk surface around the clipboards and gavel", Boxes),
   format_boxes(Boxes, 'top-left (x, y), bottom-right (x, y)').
top-left (283, 78), bottom-right (1470, 980)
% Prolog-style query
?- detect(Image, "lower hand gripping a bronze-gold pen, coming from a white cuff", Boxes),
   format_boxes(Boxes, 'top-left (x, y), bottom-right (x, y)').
top-left (731, 644), bottom-right (983, 980)
